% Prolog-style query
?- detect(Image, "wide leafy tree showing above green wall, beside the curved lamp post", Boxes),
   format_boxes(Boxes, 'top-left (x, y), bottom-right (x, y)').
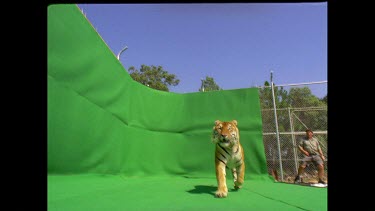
top-left (128, 64), bottom-right (180, 92)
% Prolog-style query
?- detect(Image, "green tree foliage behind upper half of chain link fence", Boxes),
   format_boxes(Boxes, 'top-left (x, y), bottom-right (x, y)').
top-left (259, 81), bottom-right (327, 132)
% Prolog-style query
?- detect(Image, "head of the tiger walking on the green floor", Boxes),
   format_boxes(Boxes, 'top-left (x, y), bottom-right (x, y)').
top-left (212, 120), bottom-right (239, 147)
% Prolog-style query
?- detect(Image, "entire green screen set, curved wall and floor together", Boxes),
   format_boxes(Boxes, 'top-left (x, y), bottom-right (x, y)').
top-left (47, 4), bottom-right (326, 210)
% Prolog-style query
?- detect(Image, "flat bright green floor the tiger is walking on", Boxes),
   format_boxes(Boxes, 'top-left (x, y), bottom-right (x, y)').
top-left (48, 175), bottom-right (327, 211)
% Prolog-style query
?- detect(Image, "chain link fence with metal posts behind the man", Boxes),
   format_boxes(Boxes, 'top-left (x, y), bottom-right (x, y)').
top-left (258, 81), bottom-right (328, 183)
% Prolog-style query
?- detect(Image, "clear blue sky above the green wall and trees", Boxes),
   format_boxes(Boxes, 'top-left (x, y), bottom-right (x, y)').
top-left (78, 2), bottom-right (328, 97)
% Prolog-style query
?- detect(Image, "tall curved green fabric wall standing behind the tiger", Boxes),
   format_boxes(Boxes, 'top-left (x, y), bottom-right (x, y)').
top-left (47, 4), bottom-right (268, 179)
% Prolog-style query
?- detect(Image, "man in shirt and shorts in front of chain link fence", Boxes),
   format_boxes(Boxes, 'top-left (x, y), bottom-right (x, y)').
top-left (294, 129), bottom-right (325, 184)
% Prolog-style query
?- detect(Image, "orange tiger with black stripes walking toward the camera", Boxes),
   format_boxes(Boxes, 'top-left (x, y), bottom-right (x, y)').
top-left (212, 120), bottom-right (245, 198)
